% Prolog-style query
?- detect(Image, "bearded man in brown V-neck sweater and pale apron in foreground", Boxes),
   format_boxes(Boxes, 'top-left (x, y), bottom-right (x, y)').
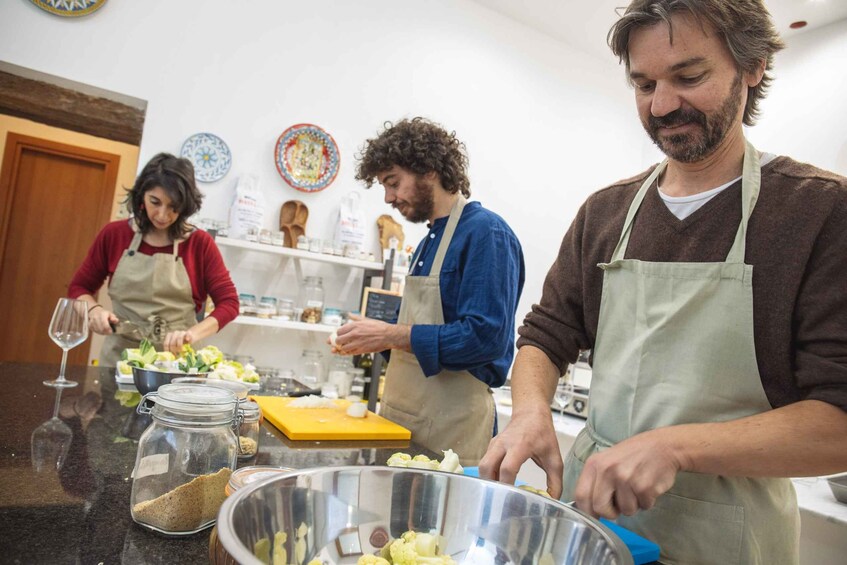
top-left (480, 0), bottom-right (847, 564)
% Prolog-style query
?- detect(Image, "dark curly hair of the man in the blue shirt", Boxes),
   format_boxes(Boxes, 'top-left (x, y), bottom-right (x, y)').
top-left (356, 117), bottom-right (471, 197)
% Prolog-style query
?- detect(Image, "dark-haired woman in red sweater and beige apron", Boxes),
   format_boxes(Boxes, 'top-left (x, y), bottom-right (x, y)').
top-left (68, 153), bottom-right (238, 365)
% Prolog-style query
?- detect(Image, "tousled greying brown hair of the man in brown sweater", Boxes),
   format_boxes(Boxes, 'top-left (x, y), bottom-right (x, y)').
top-left (607, 0), bottom-right (785, 126)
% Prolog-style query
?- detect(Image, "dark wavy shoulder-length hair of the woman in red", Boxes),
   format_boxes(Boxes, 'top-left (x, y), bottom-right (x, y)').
top-left (124, 153), bottom-right (203, 241)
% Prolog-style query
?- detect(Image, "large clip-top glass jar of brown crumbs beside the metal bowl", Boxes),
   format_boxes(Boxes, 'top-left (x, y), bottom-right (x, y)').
top-left (130, 384), bottom-right (238, 535)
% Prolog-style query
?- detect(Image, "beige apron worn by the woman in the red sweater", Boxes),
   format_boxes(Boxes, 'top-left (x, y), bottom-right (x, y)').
top-left (100, 228), bottom-right (197, 366)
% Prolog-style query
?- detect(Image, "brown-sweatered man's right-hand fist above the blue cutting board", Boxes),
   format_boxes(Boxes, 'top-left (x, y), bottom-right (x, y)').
top-left (574, 428), bottom-right (683, 520)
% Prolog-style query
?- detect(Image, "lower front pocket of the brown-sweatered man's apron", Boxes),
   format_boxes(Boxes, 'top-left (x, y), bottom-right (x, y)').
top-left (617, 492), bottom-right (744, 565)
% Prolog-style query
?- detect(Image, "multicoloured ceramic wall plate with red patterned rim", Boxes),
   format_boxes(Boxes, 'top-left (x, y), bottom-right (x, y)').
top-left (274, 124), bottom-right (339, 192)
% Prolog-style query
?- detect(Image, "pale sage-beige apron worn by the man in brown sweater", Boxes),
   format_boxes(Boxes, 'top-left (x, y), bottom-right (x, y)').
top-left (563, 143), bottom-right (800, 565)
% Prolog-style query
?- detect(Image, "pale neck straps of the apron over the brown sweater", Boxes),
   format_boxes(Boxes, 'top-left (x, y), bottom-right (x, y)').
top-left (611, 141), bottom-right (762, 263)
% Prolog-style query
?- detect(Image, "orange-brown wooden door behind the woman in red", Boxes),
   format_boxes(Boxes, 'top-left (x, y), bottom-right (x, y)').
top-left (0, 133), bottom-right (120, 365)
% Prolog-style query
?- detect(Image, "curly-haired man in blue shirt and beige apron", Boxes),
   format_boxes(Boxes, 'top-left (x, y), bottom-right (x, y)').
top-left (335, 118), bottom-right (524, 465)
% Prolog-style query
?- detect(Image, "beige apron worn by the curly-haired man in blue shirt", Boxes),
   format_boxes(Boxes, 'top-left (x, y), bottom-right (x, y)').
top-left (380, 195), bottom-right (494, 465)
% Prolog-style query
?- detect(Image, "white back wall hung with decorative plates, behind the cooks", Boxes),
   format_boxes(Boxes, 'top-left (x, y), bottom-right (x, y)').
top-left (0, 0), bottom-right (642, 368)
